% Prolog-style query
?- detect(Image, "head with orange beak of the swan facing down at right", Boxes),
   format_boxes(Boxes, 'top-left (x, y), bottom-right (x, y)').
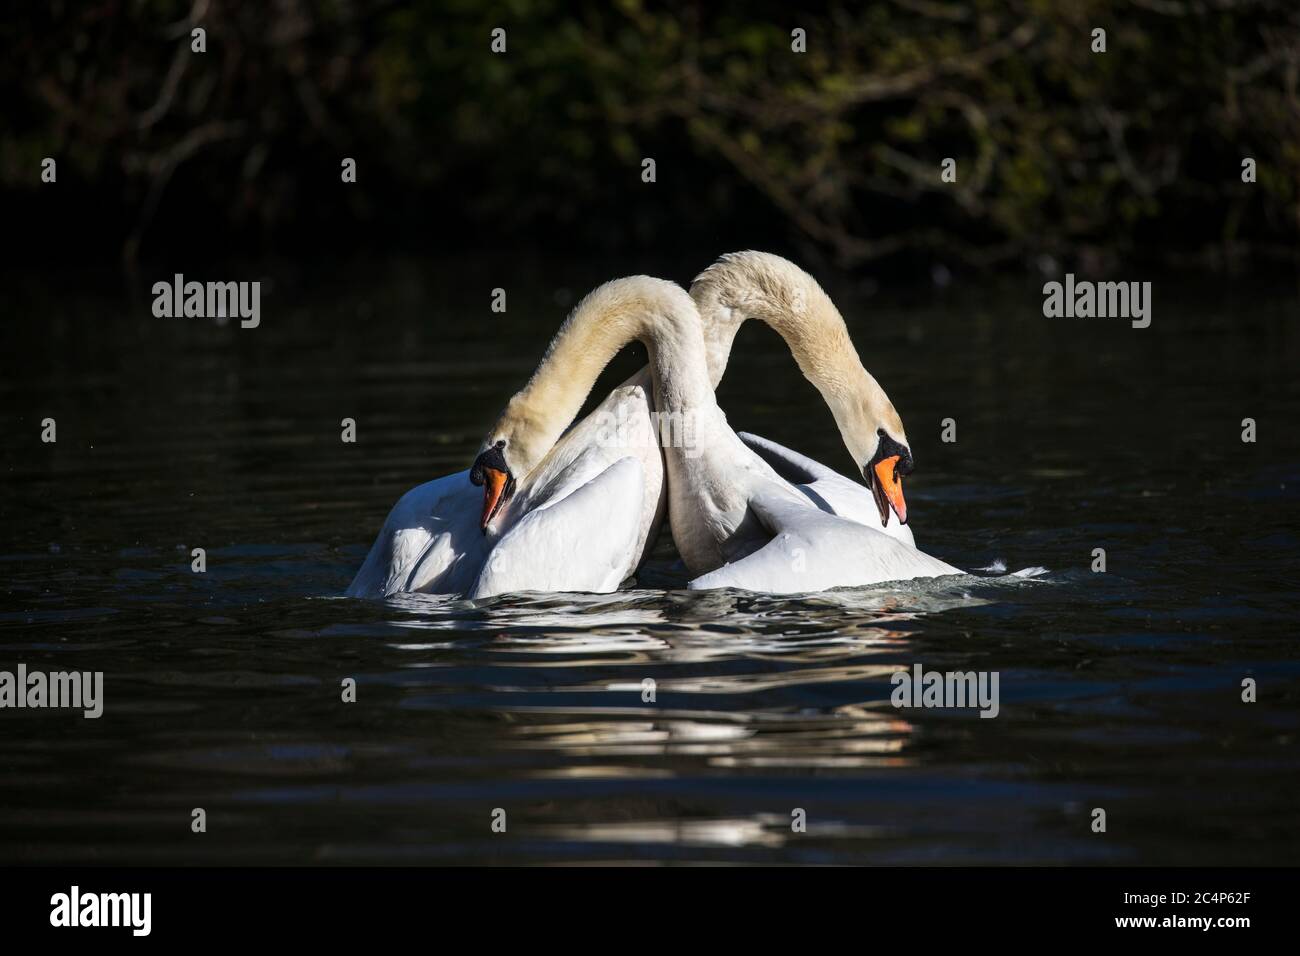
top-left (836, 385), bottom-right (913, 527)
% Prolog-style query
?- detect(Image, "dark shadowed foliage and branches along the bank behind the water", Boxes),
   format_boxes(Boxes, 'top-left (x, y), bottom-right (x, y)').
top-left (0, 0), bottom-right (1300, 277)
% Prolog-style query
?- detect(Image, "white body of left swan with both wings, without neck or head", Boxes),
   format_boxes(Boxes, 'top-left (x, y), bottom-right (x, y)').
top-left (347, 371), bottom-right (663, 598)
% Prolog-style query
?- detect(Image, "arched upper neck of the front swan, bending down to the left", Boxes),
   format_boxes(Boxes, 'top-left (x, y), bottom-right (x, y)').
top-left (499, 276), bottom-right (714, 467)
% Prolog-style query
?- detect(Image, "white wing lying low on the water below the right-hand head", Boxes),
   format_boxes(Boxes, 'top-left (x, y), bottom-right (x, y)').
top-left (688, 493), bottom-right (961, 594)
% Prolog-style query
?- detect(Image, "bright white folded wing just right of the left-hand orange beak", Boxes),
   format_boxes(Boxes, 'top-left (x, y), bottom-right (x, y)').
top-left (468, 458), bottom-right (645, 598)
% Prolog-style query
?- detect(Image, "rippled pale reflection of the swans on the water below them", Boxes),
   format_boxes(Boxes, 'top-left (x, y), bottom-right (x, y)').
top-left (343, 575), bottom-right (1036, 845)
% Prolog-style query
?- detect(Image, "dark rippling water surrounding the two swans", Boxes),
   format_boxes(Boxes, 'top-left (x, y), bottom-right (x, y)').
top-left (0, 261), bottom-right (1300, 864)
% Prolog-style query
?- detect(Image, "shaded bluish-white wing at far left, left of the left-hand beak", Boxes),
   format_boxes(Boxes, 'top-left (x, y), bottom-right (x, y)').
top-left (347, 471), bottom-right (488, 598)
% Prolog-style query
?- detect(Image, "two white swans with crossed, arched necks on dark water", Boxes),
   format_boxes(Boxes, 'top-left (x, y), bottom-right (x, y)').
top-left (347, 252), bottom-right (961, 598)
